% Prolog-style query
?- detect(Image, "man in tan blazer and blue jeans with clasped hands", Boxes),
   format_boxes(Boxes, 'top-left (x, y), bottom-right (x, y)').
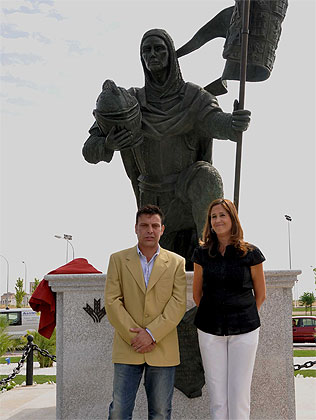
top-left (105, 205), bottom-right (186, 420)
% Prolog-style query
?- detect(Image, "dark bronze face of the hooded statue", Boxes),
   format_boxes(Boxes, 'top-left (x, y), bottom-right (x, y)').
top-left (141, 36), bottom-right (169, 72)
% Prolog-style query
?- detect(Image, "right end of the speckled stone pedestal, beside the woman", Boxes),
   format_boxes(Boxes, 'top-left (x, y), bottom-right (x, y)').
top-left (250, 270), bottom-right (301, 420)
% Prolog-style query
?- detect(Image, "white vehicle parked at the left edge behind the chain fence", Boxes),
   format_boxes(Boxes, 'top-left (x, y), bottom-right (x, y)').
top-left (0, 308), bottom-right (40, 338)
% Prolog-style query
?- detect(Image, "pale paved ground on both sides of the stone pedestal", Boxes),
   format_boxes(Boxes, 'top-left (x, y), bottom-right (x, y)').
top-left (0, 357), bottom-right (316, 420)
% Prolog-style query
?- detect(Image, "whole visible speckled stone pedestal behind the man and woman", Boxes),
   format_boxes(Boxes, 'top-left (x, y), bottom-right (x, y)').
top-left (45, 270), bottom-right (301, 420)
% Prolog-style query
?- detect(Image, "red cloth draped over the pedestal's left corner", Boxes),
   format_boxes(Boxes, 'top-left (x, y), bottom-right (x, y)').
top-left (29, 258), bottom-right (102, 338)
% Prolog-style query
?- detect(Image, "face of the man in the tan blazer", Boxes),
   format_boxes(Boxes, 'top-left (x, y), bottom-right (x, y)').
top-left (135, 214), bottom-right (165, 250)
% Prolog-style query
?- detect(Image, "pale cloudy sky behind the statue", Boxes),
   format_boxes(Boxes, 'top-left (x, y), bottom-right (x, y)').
top-left (0, 0), bottom-right (316, 300)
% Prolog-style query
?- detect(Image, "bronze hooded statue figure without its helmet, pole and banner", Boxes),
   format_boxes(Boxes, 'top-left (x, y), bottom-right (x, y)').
top-left (83, 29), bottom-right (250, 269)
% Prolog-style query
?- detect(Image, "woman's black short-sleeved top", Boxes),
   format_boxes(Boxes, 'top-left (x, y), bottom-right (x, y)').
top-left (192, 245), bottom-right (265, 335)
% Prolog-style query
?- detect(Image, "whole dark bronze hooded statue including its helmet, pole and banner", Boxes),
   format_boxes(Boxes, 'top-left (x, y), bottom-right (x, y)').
top-left (83, 0), bottom-right (287, 270)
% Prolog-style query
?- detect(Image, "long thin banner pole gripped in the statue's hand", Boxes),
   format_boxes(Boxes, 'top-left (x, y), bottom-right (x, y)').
top-left (234, 0), bottom-right (250, 211)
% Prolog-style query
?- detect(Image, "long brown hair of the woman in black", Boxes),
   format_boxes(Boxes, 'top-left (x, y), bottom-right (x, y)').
top-left (200, 198), bottom-right (251, 256)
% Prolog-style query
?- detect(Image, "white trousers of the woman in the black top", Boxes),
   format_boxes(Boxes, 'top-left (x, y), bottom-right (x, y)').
top-left (198, 328), bottom-right (260, 420)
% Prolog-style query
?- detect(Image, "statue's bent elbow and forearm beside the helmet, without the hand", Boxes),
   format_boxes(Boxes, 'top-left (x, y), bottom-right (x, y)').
top-left (82, 122), bottom-right (114, 163)
